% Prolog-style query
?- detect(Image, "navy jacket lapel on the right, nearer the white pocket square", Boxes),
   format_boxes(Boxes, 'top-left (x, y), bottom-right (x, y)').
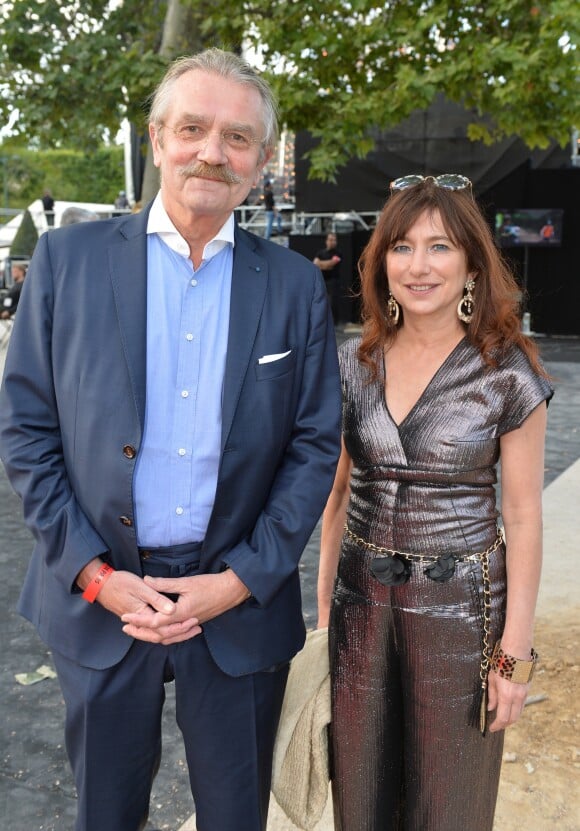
top-left (222, 228), bottom-right (268, 451)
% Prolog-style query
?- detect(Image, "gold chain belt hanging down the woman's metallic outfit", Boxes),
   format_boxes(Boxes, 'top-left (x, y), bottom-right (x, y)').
top-left (344, 522), bottom-right (505, 735)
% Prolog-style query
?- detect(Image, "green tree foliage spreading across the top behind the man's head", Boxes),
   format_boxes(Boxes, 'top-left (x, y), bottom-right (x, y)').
top-left (0, 0), bottom-right (580, 179)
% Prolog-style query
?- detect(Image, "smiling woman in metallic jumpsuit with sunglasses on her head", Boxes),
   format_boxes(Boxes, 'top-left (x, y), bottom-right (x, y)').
top-left (318, 174), bottom-right (552, 831)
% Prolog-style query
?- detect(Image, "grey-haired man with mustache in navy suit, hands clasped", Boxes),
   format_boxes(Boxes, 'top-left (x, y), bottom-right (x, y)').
top-left (0, 49), bottom-right (340, 831)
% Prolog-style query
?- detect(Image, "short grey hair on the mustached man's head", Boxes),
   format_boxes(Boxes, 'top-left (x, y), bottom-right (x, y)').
top-left (149, 48), bottom-right (278, 158)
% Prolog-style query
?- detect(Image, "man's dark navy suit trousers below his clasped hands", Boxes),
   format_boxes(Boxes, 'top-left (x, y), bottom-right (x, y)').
top-left (53, 550), bottom-right (288, 831)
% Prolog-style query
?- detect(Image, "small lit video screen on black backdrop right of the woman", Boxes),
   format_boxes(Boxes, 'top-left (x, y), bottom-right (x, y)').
top-left (495, 208), bottom-right (564, 248)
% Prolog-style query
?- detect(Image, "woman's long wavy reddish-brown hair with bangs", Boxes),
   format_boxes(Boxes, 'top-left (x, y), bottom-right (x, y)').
top-left (358, 179), bottom-right (546, 379)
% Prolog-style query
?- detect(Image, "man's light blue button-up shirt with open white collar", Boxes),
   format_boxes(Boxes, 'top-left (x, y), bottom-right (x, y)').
top-left (133, 195), bottom-right (234, 547)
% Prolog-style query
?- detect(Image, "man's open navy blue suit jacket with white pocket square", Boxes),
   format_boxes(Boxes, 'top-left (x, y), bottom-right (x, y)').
top-left (0, 206), bottom-right (340, 675)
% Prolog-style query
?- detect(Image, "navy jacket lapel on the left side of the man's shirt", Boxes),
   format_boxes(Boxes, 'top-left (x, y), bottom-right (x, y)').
top-left (107, 210), bottom-right (149, 427)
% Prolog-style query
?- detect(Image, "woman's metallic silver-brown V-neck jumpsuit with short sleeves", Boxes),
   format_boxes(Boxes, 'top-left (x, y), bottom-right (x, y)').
top-left (330, 338), bottom-right (552, 831)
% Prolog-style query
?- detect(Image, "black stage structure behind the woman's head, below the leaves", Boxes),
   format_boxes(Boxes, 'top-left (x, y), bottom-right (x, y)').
top-left (289, 96), bottom-right (580, 336)
